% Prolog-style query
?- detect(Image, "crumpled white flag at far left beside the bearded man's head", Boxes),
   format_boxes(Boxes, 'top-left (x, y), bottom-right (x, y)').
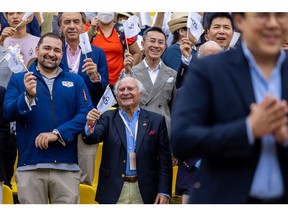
top-left (4, 44), bottom-right (24, 73)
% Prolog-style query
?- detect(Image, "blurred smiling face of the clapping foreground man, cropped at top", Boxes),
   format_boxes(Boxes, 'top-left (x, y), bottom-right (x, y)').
top-left (235, 13), bottom-right (288, 59)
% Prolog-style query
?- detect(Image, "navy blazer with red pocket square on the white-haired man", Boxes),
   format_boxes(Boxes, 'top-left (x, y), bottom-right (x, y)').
top-left (83, 109), bottom-right (172, 204)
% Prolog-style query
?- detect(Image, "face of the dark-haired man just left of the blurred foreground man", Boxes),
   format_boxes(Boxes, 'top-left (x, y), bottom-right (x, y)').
top-left (206, 17), bottom-right (233, 49)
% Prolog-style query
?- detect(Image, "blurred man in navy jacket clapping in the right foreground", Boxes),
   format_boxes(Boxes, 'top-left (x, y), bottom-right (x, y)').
top-left (171, 13), bottom-right (288, 204)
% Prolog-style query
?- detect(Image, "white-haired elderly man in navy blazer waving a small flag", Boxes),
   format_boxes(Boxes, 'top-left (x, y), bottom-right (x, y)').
top-left (84, 77), bottom-right (172, 204)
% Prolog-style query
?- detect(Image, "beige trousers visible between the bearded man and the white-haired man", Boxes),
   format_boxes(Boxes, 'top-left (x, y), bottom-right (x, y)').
top-left (77, 134), bottom-right (98, 186)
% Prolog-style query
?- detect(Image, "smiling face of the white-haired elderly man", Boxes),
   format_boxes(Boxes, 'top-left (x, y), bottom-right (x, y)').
top-left (116, 77), bottom-right (141, 111)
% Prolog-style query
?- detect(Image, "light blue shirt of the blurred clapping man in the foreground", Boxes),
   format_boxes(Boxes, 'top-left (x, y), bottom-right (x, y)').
top-left (242, 42), bottom-right (285, 199)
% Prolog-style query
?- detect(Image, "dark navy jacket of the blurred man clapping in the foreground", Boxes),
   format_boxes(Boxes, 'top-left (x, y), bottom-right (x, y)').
top-left (171, 47), bottom-right (288, 203)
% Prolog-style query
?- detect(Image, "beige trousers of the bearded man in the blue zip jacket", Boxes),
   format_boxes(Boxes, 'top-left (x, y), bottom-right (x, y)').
top-left (15, 169), bottom-right (81, 204)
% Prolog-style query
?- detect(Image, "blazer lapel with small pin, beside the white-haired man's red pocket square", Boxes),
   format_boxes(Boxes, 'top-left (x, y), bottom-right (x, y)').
top-left (136, 109), bottom-right (149, 154)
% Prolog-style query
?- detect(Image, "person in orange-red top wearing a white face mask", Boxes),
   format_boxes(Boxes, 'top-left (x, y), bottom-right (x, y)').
top-left (88, 12), bottom-right (141, 89)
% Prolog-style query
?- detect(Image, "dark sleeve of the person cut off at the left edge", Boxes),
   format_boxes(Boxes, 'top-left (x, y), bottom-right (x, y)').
top-left (0, 86), bottom-right (10, 182)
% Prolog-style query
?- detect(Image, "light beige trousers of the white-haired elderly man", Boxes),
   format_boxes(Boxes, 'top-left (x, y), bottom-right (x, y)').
top-left (116, 181), bottom-right (144, 204)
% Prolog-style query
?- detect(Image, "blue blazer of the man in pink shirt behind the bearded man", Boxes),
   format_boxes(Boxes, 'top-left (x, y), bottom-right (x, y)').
top-left (60, 42), bottom-right (108, 107)
